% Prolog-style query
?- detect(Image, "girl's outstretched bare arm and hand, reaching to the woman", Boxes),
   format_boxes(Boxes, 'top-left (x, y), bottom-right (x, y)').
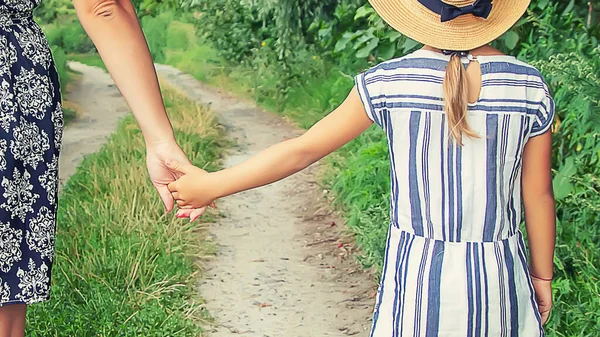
top-left (169, 88), bottom-right (373, 208)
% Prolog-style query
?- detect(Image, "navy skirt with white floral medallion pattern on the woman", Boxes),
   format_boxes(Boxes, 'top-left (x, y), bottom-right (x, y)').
top-left (0, 0), bottom-right (63, 306)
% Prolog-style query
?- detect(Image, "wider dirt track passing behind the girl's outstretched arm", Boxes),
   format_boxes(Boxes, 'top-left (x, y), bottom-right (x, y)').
top-left (157, 65), bottom-right (374, 337)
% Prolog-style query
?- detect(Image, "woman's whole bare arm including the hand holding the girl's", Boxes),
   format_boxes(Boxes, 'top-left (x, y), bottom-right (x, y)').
top-left (73, 0), bottom-right (204, 220)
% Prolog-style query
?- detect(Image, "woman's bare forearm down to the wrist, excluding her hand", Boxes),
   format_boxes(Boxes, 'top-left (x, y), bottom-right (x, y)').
top-left (73, 0), bottom-right (174, 145)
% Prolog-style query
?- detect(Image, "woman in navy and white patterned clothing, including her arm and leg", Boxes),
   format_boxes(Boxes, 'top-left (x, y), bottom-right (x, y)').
top-left (0, 0), bottom-right (203, 337)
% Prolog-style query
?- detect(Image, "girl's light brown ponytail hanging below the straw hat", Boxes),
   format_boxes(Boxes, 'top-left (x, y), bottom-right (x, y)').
top-left (443, 54), bottom-right (479, 145)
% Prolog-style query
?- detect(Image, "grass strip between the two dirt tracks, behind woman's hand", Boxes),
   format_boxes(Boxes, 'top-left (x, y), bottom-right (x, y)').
top-left (26, 85), bottom-right (224, 337)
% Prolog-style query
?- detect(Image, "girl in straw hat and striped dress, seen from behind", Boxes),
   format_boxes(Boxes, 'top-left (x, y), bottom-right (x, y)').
top-left (169, 0), bottom-right (555, 337)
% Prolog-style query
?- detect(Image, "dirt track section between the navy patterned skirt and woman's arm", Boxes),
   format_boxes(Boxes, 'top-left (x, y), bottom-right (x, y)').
top-left (59, 62), bottom-right (129, 186)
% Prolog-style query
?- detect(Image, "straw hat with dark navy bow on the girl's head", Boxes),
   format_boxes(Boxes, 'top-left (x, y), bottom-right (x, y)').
top-left (369, 0), bottom-right (530, 51)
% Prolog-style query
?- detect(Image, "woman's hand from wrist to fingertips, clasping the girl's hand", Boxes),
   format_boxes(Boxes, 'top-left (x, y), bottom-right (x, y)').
top-left (146, 141), bottom-right (206, 221)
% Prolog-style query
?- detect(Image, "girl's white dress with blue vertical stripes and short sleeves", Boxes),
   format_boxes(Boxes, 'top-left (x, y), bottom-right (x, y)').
top-left (356, 50), bottom-right (554, 337)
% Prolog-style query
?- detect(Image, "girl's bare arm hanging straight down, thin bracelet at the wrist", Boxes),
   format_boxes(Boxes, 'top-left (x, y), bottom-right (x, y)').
top-left (522, 131), bottom-right (556, 323)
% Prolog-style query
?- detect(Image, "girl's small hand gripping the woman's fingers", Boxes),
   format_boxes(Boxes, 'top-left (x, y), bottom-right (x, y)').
top-left (167, 160), bottom-right (217, 210)
